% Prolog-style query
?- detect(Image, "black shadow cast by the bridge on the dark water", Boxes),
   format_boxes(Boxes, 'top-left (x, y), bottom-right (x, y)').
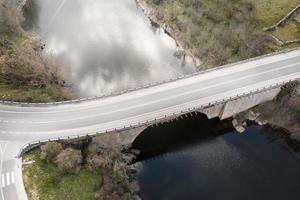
top-left (132, 113), bottom-right (234, 162)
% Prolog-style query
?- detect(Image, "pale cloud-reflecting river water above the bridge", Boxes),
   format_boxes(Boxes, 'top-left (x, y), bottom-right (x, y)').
top-left (23, 0), bottom-right (195, 96)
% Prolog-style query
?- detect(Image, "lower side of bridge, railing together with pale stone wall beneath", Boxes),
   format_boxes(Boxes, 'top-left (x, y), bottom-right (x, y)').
top-left (17, 80), bottom-right (294, 157)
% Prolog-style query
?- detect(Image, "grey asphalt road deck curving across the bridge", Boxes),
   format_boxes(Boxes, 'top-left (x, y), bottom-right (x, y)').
top-left (0, 50), bottom-right (300, 141)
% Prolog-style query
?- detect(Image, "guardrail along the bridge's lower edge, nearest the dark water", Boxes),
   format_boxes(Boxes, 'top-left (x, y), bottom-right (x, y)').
top-left (17, 79), bottom-right (298, 157)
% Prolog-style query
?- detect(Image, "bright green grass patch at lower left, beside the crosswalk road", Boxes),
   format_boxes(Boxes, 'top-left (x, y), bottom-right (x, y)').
top-left (23, 150), bottom-right (102, 200)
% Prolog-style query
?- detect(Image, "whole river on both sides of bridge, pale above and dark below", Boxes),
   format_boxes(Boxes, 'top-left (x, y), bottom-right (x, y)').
top-left (23, 0), bottom-right (300, 200)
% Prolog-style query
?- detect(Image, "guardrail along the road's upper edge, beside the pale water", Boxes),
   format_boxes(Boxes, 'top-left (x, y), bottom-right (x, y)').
top-left (0, 48), bottom-right (300, 107)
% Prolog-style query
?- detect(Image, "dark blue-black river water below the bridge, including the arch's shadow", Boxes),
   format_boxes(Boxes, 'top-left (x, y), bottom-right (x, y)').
top-left (134, 116), bottom-right (300, 200)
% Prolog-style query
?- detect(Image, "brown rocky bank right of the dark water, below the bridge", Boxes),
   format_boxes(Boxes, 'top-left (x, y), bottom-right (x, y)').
top-left (233, 81), bottom-right (300, 148)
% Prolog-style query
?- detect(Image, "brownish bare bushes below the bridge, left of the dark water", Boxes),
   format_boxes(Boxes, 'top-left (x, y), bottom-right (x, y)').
top-left (40, 136), bottom-right (139, 200)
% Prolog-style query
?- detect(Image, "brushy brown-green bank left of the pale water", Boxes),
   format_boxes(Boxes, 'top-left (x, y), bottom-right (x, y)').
top-left (0, 1), bottom-right (71, 102)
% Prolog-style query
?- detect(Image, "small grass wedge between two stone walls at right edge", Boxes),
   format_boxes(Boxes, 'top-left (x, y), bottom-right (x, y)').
top-left (273, 22), bottom-right (300, 42)
